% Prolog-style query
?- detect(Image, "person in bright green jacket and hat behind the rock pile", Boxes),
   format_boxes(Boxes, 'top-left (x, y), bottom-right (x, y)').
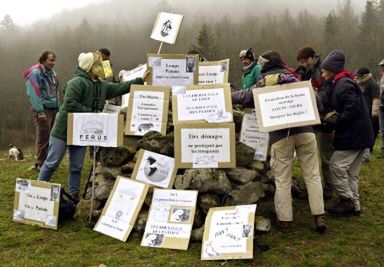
top-left (239, 48), bottom-right (260, 90)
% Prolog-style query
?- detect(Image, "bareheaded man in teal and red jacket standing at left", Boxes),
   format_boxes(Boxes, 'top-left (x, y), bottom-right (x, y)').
top-left (23, 50), bottom-right (60, 170)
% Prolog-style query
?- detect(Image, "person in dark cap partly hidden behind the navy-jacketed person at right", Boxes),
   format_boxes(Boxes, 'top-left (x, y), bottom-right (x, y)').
top-left (354, 67), bottom-right (380, 162)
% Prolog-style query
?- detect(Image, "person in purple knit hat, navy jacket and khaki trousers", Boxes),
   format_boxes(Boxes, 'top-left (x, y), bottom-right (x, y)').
top-left (321, 50), bottom-right (373, 218)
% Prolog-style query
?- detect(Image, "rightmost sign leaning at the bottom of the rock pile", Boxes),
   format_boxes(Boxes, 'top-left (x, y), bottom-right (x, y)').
top-left (201, 205), bottom-right (256, 260)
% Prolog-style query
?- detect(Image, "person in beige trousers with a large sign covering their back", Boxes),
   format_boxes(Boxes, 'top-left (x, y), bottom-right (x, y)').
top-left (232, 51), bottom-right (327, 233)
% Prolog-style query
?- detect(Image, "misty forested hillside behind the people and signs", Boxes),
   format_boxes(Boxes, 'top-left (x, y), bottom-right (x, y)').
top-left (0, 0), bottom-right (384, 150)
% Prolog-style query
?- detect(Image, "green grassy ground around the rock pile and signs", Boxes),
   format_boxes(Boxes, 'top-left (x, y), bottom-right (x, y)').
top-left (0, 147), bottom-right (384, 266)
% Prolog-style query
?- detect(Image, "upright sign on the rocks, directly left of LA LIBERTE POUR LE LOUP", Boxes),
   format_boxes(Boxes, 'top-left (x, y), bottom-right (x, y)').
top-left (125, 84), bottom-right (171, 136)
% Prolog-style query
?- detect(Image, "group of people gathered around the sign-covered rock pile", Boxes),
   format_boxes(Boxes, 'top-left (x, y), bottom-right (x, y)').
top-left (24, 46), bottom-right (384, 233)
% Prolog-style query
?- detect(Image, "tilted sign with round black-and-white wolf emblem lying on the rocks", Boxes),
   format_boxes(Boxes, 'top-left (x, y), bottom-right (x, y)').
top-left (131, 149), bottom-right (177, 188)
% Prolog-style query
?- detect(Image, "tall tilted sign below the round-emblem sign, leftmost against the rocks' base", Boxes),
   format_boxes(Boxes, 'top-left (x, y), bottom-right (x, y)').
top-left (93, 176), bottom-right (149, 242)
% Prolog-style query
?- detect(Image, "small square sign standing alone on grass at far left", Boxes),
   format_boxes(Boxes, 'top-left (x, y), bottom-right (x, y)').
top-left (12, 178), bottom-right (61, 230)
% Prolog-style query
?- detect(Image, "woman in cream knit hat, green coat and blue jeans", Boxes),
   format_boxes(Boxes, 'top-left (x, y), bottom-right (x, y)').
top-left (38, 52), bottom-right (149, 199)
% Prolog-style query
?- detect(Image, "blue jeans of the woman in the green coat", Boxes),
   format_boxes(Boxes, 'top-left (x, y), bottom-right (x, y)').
top-left (38, 136), bottom-right (87, 194)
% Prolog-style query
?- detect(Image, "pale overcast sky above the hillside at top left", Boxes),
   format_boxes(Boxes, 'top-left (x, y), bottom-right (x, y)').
top-left (0, 0), bottom-right (105, 26)
